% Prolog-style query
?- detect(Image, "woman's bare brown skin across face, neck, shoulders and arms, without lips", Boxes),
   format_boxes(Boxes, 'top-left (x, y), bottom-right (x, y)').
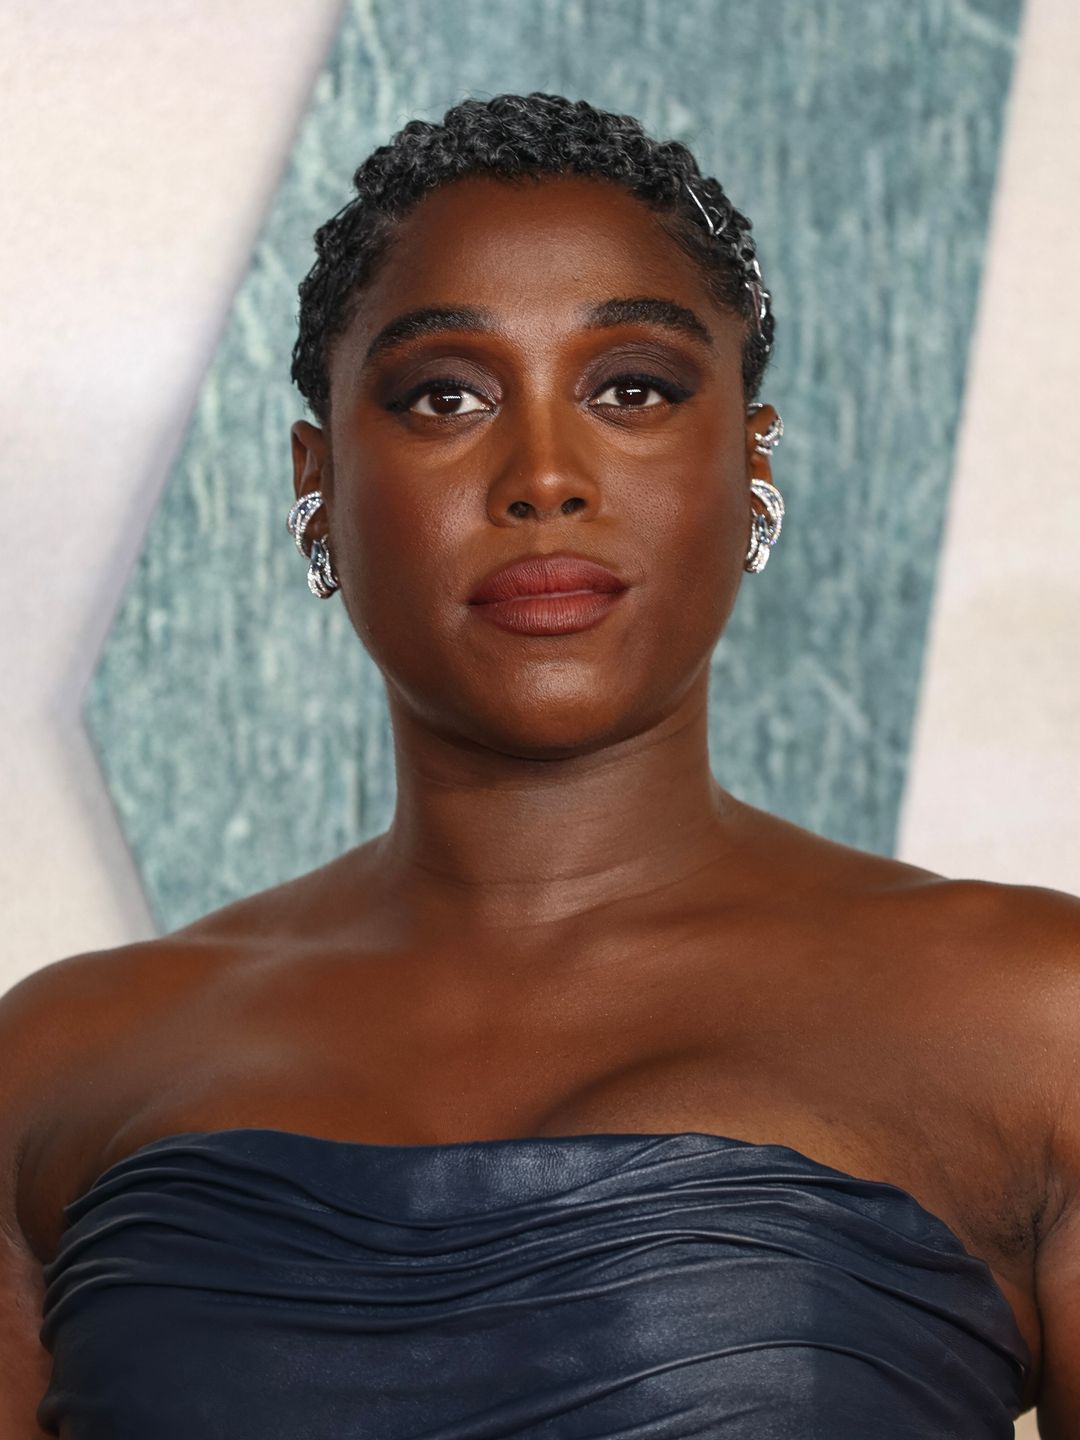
top-left (0, 179), bottom-right (1080, 1440)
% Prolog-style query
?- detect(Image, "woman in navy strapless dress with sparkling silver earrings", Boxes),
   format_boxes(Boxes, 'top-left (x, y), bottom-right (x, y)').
top-left (0, 95), bottom-right (1080, 1440)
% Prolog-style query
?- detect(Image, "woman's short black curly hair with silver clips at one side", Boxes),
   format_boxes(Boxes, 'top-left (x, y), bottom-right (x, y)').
top-left (292, 92), bottom-right (775, 423)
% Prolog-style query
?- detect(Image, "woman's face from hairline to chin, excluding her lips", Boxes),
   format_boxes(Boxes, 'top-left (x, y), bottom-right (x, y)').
top-left (294, 177), bottom-right (766, 759)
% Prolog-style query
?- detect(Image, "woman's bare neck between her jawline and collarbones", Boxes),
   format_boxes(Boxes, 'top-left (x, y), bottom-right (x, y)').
top-left (373, 674), bottom-right (737, 937)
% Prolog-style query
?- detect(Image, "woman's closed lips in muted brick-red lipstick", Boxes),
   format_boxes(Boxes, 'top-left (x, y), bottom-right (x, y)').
top-left (469, 553), bottom-right (628, 635)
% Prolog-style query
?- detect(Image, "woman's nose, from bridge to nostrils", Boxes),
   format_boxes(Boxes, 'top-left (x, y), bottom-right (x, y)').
top-left (487, 399), bottom-right (600, 526)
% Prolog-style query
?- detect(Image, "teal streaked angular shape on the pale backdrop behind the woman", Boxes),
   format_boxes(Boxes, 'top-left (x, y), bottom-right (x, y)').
top-left (85, 0), bottom-right (1021, 932)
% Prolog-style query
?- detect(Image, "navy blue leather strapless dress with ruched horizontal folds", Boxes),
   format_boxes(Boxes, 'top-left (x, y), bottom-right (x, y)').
top-left (37, 1129), bottom-right (1030, 1440)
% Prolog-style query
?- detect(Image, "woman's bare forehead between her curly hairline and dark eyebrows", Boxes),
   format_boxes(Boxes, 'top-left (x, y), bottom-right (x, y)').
top-left (348, 176), bottom-right (737, 348)
